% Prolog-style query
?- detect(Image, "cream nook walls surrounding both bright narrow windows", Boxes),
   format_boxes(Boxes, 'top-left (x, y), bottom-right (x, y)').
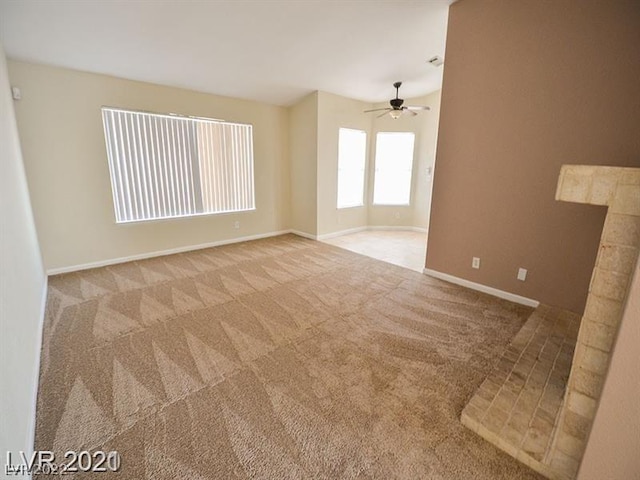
top-left (289, 91), bottom-right (440, 236)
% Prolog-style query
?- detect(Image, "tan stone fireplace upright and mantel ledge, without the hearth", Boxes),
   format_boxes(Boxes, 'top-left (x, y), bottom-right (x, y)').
top-left (551, 165), bottom-right (640, 479)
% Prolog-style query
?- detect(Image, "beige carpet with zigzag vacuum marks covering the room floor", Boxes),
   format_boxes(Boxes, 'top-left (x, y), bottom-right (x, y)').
top-left (36, 235), bottom-right (541, 480)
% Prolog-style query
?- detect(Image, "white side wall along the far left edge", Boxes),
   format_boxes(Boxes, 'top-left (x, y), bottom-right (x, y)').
top-left (0, 45), bottom-right (47, 471)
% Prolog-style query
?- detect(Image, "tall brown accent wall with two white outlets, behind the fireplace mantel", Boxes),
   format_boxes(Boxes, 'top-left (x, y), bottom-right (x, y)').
top-left (426, 0), bottom-right (640, 313)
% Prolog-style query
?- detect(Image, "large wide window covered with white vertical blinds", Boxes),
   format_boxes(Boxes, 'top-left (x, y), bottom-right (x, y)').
top-left (102, 108), bottom-right (255, 223)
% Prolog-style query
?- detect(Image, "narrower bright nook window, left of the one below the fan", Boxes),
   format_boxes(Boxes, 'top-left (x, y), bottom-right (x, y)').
top-left (338, 128), bottom-right (367, 208)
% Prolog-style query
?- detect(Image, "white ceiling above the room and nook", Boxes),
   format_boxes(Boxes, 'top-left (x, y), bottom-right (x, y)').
top-left (0, 0), bottom-right (453, 105)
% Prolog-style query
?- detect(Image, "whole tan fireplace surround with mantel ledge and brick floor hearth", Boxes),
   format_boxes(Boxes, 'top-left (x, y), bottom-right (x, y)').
top-left (461, 165), bottom-right (640, 480)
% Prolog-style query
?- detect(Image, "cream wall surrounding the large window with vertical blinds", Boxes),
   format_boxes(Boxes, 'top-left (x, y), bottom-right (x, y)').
top-left (9, 61), bottom-right (290, 269)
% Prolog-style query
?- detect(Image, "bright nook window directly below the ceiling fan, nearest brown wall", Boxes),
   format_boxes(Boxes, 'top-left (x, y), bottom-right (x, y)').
top-left (373, 132), bottom-right (415, 205)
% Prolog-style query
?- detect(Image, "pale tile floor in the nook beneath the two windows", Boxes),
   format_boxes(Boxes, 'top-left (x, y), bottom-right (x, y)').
top-left (323, 230), bottom-right (427, 273)
